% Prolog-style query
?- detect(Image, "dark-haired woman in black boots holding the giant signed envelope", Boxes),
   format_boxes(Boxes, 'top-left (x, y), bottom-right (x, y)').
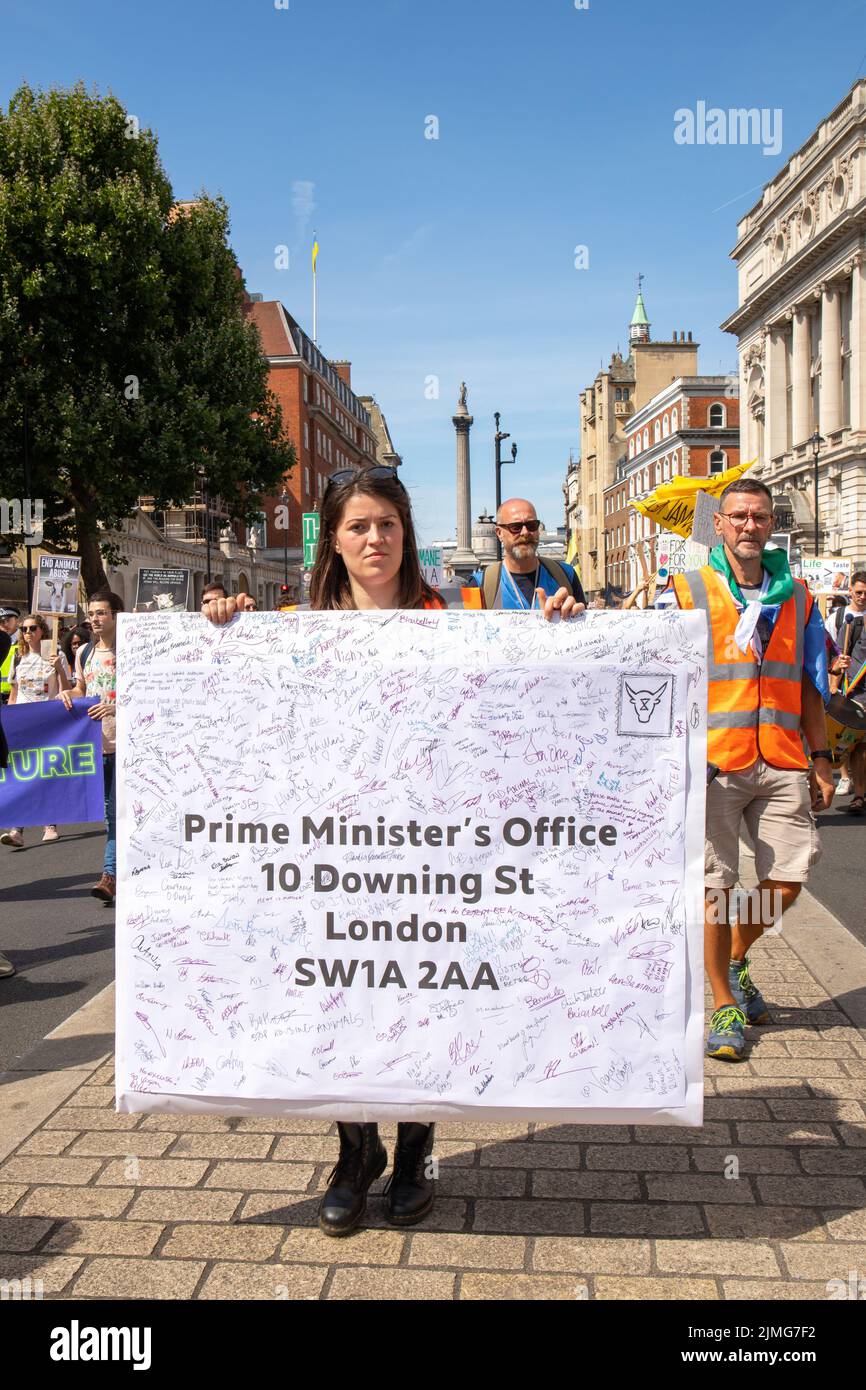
top-left (202, 466), bottom-right (577, 1236)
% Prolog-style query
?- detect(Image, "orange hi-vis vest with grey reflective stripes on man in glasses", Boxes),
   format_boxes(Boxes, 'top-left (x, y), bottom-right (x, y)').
top-left (674, 564), bottom-right (812, 773)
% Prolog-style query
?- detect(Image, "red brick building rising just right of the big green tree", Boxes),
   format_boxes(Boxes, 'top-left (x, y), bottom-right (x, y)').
top-left (245, 297), bottom-right (377, 564)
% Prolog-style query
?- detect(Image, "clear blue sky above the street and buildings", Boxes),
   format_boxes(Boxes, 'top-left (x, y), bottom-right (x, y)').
top-left (0, 0), bottom-right (866, 542)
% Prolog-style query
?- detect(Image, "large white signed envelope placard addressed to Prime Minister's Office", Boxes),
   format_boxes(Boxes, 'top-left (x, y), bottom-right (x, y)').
top-left (117, 610), bottom-right (706, 1125)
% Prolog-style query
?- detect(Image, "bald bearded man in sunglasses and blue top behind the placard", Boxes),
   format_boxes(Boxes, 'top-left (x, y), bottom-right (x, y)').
top-left (473, 498), bottom-right (587, 617)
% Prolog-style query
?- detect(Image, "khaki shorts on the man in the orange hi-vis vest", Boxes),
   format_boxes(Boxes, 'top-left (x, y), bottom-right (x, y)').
top-left (703, 758), bottom-right (822, 888)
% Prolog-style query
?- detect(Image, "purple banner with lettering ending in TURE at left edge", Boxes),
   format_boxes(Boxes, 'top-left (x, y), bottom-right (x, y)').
top-left (0, 699), bottom-right (106, 826)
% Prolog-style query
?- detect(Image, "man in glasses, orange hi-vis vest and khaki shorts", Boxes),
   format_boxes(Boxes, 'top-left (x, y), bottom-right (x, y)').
top-left (674, 478), bottom-right (834, 1062)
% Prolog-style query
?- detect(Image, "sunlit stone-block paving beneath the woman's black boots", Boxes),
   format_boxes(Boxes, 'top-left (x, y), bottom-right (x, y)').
top-left (0, 895), bottom-right (866, 1300)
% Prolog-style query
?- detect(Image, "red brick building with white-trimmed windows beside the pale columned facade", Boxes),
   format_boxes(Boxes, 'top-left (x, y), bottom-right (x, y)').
top-left (605, 377), bottom-right (740, 594)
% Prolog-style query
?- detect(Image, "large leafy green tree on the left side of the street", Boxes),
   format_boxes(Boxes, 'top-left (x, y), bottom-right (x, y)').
top-left (0, 83), bottom-right (296, 592)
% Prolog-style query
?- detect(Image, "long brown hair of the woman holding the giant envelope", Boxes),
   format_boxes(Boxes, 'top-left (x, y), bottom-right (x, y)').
top-left (310, 473), bottom-right (443, 609)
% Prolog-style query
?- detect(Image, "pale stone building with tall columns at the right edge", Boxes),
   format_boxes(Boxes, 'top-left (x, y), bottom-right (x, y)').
top-left (721, 79), bottom-right (866, 563)
